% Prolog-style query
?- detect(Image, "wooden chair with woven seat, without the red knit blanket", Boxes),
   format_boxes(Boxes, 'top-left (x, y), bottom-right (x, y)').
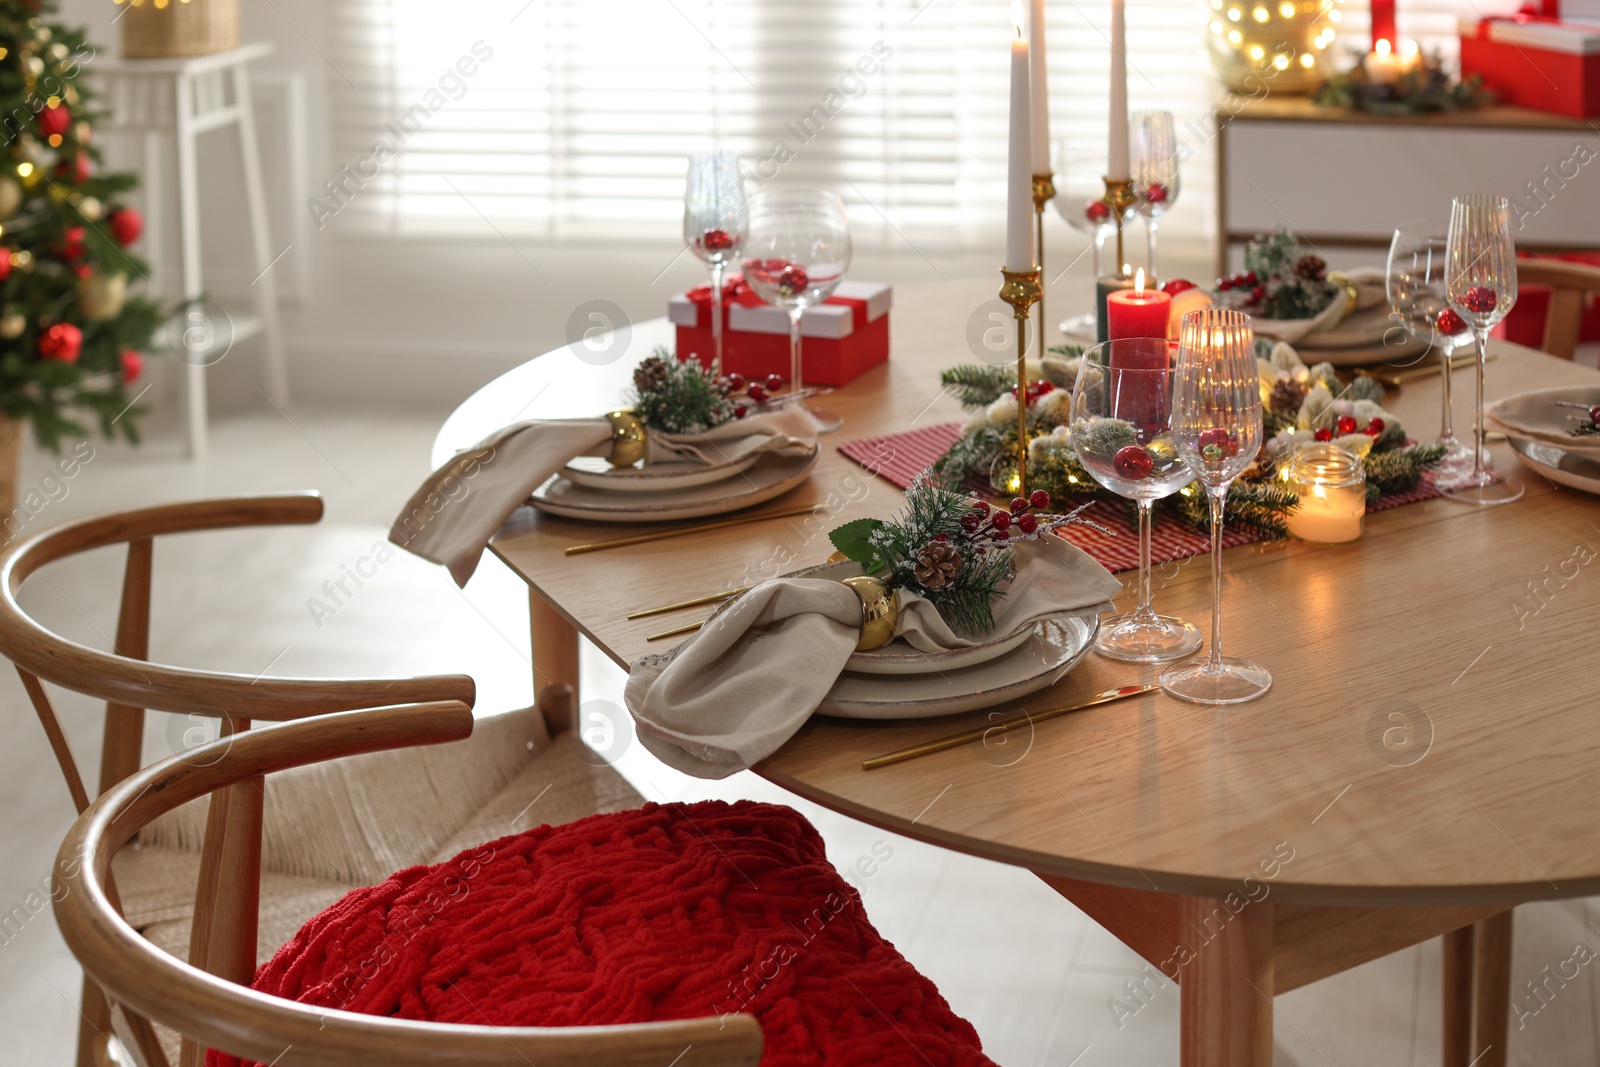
top-left (0, 493), bottom-right (638, 1067)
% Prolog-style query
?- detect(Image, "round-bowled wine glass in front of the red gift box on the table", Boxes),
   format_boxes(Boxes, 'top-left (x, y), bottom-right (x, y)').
top-left (744, 189), bottom-right (850, 434)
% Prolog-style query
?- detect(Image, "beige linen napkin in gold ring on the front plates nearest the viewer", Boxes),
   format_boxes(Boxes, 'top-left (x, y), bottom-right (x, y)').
top-left (624, 536), bottom-right (1122, 777)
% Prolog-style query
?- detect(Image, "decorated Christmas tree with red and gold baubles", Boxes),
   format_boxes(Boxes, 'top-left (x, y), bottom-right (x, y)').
top-left (0, 0), bottom-right (163, 463)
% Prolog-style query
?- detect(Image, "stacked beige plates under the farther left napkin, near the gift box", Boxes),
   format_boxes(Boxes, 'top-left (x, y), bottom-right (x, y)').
top-left (528, 451), bottom-right (818, 523)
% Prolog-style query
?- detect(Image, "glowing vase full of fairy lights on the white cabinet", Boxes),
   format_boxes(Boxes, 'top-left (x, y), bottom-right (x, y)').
top-left (1206, 0), bottom-right (1344, 96)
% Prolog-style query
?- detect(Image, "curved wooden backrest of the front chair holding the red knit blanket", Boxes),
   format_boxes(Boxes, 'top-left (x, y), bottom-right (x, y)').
top-left (54, 702), bottom-right (762, 1067)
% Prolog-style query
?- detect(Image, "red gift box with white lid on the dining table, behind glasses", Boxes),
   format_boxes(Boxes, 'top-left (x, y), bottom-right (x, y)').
top-left (667, 274), bottom-right (894, 386)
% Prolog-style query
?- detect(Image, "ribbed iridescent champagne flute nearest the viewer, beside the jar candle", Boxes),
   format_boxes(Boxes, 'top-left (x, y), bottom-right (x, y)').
top-left (1162, 307), bottom-right (1272, 704)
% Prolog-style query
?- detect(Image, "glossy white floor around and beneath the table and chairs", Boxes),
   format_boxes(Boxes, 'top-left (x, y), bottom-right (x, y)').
top-left (0, 410), bottom-right (1600, 1067)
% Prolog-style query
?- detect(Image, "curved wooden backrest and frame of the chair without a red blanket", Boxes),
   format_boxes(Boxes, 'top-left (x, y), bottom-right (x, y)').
top-left (0, 493), bottom-right (475, 1067)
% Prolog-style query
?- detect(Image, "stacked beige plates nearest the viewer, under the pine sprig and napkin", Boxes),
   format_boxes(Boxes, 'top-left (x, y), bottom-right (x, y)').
top-left (789, 563), bottom-right (1099, 718)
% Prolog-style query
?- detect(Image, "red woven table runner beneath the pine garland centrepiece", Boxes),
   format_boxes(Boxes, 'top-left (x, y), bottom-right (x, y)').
top-left (838, 422), bottom-right (1438, 571)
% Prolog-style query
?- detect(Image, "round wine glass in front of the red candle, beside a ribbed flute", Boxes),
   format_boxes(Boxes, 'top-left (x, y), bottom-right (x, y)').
top-left (1072, 338), bottom-right (1202, 664)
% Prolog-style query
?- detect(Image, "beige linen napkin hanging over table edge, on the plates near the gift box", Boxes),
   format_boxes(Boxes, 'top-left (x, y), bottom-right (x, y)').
top-left (389, 405), bottom-right (816, 585)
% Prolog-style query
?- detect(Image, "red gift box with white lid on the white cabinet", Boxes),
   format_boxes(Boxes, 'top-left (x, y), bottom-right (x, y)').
top-left (1461, 14), bottom-right (1600, 118)
